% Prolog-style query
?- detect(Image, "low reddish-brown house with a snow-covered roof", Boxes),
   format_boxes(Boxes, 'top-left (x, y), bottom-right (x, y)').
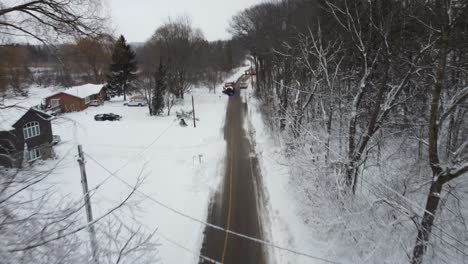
top-left (45, 84), bottom-right (106, 113)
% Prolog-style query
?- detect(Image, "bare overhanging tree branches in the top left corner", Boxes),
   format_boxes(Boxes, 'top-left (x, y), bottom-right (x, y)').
top-left (0, 0), bottom-right (105, 43)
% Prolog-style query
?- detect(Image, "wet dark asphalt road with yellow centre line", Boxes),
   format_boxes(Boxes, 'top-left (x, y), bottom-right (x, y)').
top-left (200, 77), bottom-right (266, 264)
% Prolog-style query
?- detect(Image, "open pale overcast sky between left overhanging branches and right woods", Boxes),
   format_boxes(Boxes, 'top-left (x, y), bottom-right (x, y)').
top-left (106, 0), bottom-right (264, 42)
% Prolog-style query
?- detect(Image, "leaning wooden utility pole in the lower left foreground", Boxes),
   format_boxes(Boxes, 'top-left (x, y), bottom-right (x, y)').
top-left (78, 145), bottom-right (99, 264)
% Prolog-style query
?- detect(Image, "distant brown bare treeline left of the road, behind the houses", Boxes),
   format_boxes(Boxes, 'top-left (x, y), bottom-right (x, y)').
top-left (0, 17), bottom-right (245, 98)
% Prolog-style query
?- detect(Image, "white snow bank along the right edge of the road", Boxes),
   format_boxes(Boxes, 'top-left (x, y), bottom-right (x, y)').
top-left (244, 82), bottom-right (333, 264)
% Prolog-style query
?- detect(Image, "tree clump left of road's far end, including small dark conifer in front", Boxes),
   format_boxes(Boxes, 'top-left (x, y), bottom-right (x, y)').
top-left (131, 17), bottom-right (245, 115)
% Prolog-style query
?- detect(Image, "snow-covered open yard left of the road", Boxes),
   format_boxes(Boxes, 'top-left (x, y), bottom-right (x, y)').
top-left (5, 69), bottom-right (249, 263)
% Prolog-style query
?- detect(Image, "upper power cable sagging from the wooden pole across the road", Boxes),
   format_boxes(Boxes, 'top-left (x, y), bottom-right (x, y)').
top-left (85, 153), bottom-right (340, 264)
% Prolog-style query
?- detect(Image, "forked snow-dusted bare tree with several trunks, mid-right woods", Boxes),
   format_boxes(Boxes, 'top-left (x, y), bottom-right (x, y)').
top-left (327, 0), bottom-right (435, 192)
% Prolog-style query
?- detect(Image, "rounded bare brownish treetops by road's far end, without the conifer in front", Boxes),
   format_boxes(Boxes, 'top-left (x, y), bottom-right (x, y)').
top-left (137, 16), bottom-right (245, 97)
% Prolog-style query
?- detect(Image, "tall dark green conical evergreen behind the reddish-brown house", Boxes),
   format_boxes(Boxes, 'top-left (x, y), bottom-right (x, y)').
top-left (107, 35), bottom-right (138, 100)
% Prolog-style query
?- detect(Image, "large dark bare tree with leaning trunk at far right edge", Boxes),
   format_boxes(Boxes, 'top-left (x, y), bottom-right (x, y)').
top-left (411, 1), bottom-right (468, 264)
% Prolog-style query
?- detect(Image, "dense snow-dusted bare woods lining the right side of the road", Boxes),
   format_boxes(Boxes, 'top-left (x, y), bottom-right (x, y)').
top-left (230, 0), bottom-right (468, 263)
